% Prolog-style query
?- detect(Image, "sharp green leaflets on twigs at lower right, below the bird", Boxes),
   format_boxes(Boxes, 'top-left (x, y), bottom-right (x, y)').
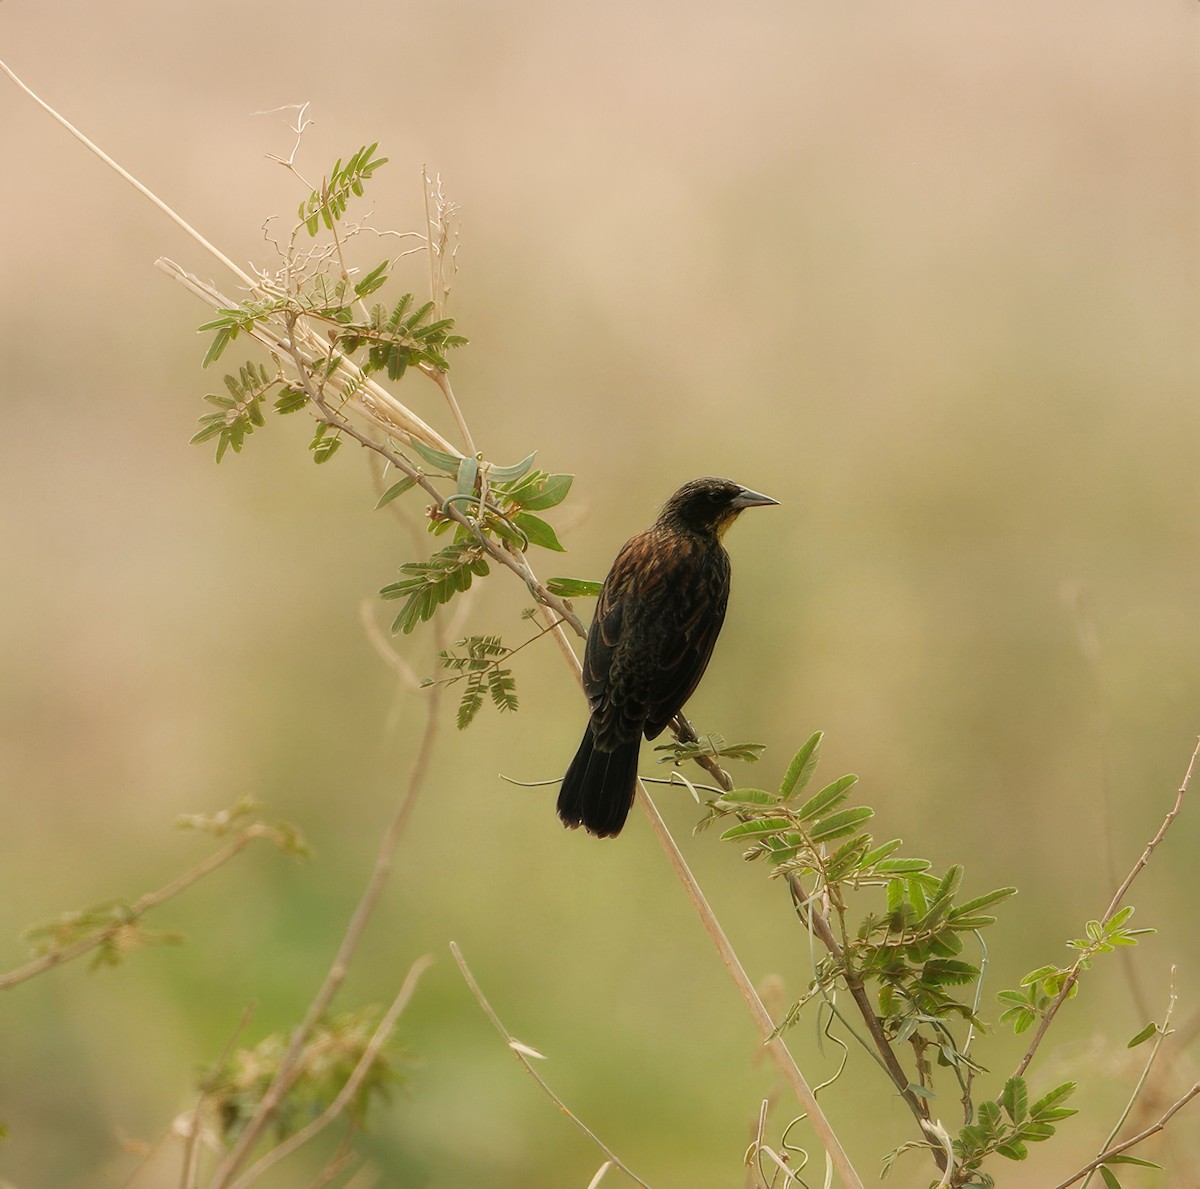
top-left (698, 732), bottom-right (1171, 1189)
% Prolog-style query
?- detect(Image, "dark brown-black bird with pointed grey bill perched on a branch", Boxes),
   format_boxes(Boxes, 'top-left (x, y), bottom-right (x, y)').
top-left (558, 476), bottom-right (779, 837)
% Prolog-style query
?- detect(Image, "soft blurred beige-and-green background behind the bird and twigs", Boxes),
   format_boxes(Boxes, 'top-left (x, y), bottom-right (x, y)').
top-left (0, 0), bottom-right (1200, 1189)
